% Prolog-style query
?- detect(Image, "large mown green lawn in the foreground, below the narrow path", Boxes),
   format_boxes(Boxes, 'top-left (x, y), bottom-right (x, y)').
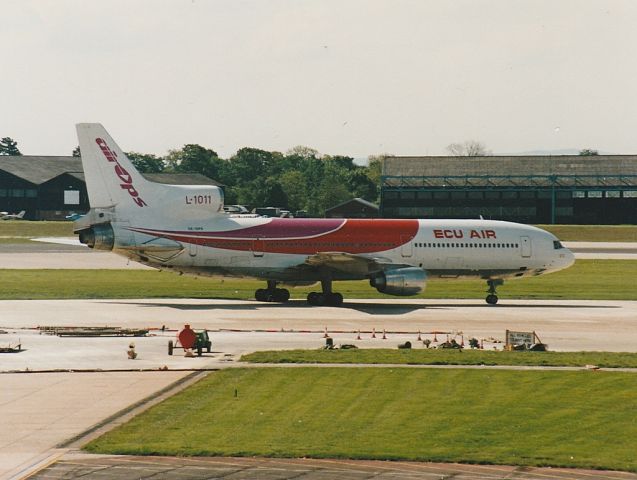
top-left (86, 368), bottom-right (637, 471)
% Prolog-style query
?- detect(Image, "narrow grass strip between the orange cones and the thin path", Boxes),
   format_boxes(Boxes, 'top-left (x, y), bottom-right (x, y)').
top-left (241, 348), bottom-right (637, 368)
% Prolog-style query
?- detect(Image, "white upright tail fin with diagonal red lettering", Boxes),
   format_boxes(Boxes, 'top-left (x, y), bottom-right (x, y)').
top-left (76, 123), bottom-right (151, 208)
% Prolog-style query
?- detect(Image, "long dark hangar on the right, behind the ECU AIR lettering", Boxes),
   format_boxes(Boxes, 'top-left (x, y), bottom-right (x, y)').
top-left (380, 155), bottom-right (637, 224)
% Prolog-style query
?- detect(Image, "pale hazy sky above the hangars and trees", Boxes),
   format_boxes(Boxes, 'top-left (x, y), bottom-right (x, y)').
top-left (0, 0), bottom-right (637, 158)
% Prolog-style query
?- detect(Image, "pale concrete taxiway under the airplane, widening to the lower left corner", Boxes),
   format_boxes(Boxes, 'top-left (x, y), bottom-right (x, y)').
top-left (0, 299), bottom-right (637, 478)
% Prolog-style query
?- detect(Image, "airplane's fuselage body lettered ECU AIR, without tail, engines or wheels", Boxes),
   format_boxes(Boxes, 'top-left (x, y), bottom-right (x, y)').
top-left (108, 216), bottom-right (574, 282)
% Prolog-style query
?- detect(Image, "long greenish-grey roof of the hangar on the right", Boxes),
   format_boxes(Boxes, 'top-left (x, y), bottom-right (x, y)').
top-left (382, 155), bottom-right (637, 186)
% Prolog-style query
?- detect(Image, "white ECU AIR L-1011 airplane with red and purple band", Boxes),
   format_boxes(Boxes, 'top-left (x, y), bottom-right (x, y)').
top-left (74, 123), bottom-right (574, 306)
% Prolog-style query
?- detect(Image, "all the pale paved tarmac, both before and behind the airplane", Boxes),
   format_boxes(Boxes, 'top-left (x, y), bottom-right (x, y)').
top-left (0, 240), bottom-right (637, 480)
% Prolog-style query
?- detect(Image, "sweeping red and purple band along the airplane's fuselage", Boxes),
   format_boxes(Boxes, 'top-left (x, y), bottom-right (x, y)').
top-left (131, 219), bottom-right (418, 255)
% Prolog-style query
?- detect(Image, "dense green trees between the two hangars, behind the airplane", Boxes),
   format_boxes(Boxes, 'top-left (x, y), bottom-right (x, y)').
top-left (126, 144), bottom-right (381, 216)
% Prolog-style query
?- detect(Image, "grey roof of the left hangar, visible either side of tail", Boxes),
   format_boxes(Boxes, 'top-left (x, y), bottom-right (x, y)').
top-left (0, 155), bottom-right (220, 186)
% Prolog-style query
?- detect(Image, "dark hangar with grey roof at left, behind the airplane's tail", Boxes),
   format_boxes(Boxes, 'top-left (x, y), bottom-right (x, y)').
top-left (0, 155), bottom-right (219, 220)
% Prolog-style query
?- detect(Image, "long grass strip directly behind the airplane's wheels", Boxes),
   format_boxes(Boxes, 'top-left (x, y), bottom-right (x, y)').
top-left (0, 260), bottom-right (637, 300)
